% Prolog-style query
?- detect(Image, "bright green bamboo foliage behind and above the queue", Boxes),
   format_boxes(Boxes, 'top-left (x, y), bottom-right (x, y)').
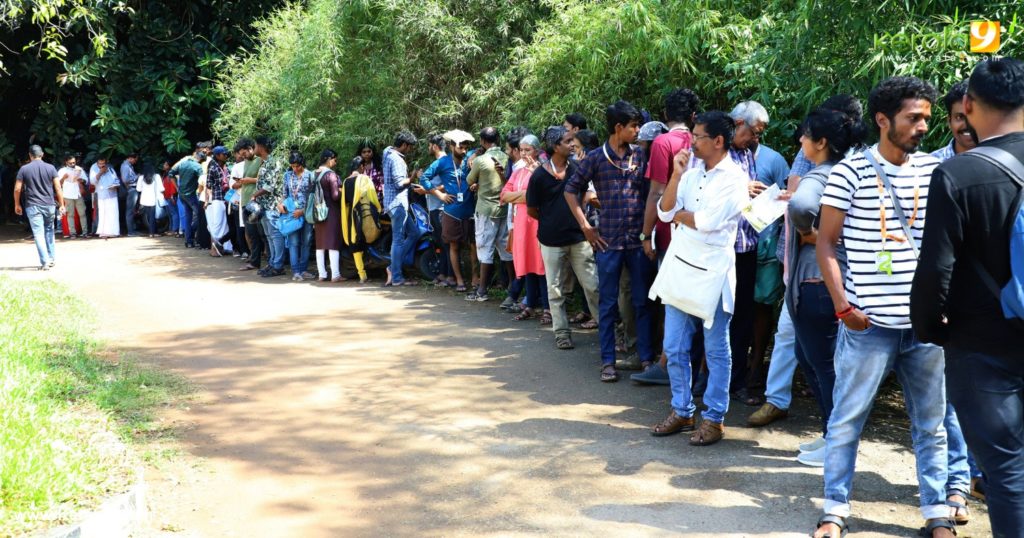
top-left (216, 0), bottom-right (1024, 157)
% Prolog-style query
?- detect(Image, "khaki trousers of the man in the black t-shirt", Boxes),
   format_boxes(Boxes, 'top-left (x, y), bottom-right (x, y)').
top-left (541, 241), bottom-right (599, 336)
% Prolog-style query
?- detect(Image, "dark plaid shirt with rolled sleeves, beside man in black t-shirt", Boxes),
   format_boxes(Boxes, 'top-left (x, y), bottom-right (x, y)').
top-left (565, 142), bottom-right (649, 250)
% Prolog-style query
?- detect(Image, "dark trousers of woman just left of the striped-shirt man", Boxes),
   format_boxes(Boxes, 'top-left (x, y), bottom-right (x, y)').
top-left (793, 282), bottom-right (839, 432)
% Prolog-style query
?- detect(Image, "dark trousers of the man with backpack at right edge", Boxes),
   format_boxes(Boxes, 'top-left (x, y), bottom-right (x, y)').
top-left (945, 346), bottom-right (1024, 538)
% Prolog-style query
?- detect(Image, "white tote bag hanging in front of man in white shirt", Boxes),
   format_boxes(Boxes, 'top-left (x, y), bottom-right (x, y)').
top-left (649, 227), bottom-right (735, 328)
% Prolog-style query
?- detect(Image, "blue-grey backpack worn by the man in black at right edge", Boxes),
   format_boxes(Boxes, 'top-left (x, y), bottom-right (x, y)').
top-left (964, 147), bottom-right (1024, 328)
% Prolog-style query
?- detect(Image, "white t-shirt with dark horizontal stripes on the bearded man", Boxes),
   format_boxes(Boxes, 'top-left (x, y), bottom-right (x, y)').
top-left (821, 146), bottom-right (939, 329)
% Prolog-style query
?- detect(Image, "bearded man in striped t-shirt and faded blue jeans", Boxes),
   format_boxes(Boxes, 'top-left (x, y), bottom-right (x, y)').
top-left (814, 77), bottom-right (955, 538)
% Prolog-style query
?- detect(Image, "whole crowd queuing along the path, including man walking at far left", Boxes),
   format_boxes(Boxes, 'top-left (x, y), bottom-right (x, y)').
top-left (9, 58), bottom-right (1024, 537)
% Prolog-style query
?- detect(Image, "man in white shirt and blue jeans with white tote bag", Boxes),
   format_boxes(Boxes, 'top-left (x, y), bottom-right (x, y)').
top-left (651, 111), bottom-right (750, 446)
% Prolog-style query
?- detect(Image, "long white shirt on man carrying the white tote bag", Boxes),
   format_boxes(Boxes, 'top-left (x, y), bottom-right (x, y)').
top-left (657, 155), bottom-right (751, 313)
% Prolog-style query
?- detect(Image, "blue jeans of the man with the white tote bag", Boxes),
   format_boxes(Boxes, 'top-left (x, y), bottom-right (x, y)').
top-left (664, 299), bottom-right (732, 424)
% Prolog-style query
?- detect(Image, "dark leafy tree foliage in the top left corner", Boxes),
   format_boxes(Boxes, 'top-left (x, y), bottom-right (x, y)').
top-left (0, 0), bottom-right (282, 166)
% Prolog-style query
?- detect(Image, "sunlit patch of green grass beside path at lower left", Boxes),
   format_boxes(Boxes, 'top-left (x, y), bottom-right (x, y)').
top-left (0, 275), bottom-right (187, 536)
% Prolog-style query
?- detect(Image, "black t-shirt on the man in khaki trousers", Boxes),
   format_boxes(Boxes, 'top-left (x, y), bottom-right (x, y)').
top-left (526, 163), bottom-right (585, 247)
